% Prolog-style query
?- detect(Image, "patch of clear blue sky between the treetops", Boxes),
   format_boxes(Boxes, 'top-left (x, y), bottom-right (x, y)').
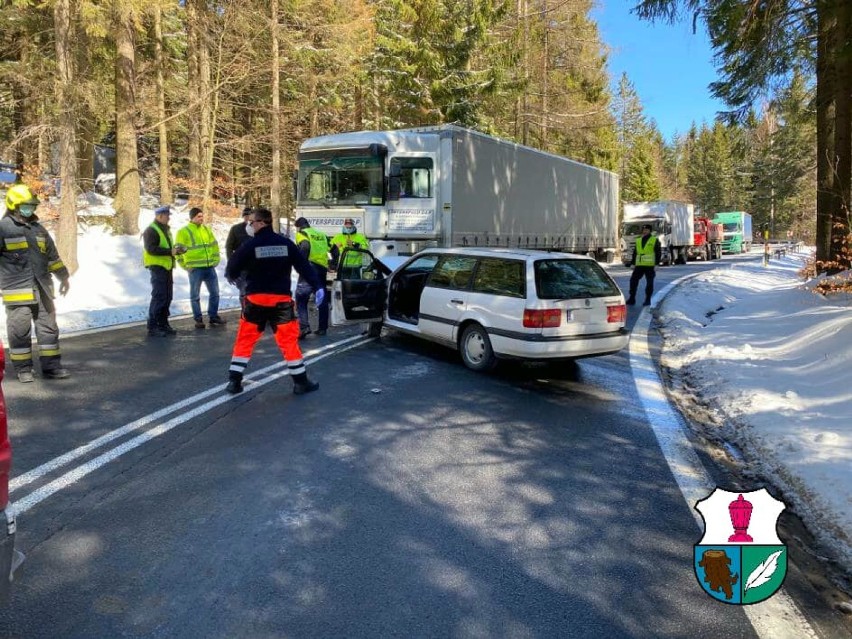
top-left (592, 0), bottom-right (725, 140)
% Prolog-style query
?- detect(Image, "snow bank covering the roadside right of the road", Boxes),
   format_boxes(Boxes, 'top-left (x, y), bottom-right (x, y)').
top-left (658, 256), bottom-right (852, 569)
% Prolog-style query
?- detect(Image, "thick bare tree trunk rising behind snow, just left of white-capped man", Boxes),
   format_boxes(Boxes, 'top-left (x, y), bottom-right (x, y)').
top-left (113, 2), bottom-right (140, 235)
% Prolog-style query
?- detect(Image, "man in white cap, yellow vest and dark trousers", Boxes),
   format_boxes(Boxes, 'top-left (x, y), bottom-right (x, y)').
top-left (142, 205), bottom-right (186, 337)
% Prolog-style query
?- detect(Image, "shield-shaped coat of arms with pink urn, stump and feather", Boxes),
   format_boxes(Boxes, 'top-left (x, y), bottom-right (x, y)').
top-left (693, 488), bottom-right (787, 605)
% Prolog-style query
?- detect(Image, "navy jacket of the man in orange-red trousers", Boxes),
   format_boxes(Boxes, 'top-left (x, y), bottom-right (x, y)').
top-left (225, 226), bottom-right (324, 295)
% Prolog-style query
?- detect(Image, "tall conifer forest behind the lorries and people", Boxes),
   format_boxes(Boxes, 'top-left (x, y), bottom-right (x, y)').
top-left (0, 0), bottom-right (852, 270)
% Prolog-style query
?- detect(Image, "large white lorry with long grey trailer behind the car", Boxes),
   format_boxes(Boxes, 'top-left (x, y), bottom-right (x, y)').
top-left (295, 125), bottom-right (619, 261)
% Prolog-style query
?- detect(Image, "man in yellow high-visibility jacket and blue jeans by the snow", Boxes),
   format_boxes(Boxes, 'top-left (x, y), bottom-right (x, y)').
top-left (177, 208), bottom-right (227, 329)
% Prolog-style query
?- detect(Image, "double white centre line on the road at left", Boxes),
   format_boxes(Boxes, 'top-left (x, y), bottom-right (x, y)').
top-left (10, 335), bottom-right (375, 515)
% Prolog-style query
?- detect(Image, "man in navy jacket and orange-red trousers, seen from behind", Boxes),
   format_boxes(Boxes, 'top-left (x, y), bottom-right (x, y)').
top-left (225, 208), bottom-right (325, 395)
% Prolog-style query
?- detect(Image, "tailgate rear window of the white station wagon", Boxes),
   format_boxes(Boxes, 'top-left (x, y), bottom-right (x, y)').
top-left (535, 259), bottom-right (621, 300)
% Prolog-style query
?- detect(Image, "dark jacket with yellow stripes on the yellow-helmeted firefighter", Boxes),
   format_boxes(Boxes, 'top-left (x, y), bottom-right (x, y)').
top-left (0, 212), bottom-right (70, 306)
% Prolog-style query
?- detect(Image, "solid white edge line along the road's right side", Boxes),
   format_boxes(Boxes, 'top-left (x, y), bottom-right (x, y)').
top-left (629, 282), bottom-right (817, 639)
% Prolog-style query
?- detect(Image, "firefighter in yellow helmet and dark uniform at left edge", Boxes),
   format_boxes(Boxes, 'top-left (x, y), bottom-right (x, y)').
top-left (0, 184), bottom-right (70, 383)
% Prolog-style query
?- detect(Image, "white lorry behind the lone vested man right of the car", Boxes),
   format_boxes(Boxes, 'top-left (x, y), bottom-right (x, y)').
top-left (621, 200), bottom-right (695, 266)
